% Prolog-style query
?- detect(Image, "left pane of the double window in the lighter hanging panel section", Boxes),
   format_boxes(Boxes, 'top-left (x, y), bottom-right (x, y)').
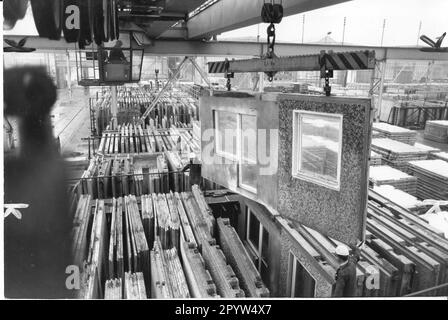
top-left (214, 110), bottom-right (238, 160)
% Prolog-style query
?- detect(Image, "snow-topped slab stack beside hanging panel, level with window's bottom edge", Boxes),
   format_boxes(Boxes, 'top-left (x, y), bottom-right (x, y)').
top-left (369, 166), bottom-right (417, 195)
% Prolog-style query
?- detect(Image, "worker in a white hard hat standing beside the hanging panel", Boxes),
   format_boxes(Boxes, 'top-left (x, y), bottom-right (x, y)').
top-left (332, 244), bottom-right (359, 297)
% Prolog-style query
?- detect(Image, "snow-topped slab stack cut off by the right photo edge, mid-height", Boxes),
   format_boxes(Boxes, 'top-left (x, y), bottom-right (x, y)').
top-left (409, 160), bottom-right (448, 200)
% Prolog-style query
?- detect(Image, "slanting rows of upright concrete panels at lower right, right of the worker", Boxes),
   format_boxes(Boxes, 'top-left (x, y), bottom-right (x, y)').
top-left (367, 190), bottom-right (448, 296)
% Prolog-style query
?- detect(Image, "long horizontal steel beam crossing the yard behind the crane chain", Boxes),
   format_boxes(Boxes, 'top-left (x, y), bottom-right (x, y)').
top-left (4, 35), bottom-right (448, 61)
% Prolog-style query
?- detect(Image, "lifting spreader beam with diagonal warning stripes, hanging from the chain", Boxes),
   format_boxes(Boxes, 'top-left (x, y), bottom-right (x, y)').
top-left (208, 51), bottom-right (375, 73)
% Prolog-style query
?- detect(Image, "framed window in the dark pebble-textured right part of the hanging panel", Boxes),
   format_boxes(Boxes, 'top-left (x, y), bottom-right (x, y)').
top-left (292, 110), bottom-right (342, 190)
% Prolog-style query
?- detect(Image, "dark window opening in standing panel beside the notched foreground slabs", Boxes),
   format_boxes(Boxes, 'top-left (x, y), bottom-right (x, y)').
top-left (246, 208), bottom-right (269, 283)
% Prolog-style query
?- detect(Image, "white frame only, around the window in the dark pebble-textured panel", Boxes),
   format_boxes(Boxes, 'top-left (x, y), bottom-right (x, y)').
top-left (291, 110), bottom-right (344, 191)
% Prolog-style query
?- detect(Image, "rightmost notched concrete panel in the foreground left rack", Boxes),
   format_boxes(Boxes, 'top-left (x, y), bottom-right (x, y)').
top-left (217, 218), bottom-right (269, 298)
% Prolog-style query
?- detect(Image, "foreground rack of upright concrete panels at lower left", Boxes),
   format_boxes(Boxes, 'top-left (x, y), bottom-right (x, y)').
top-left (72, 186), bottom-right (250, 299)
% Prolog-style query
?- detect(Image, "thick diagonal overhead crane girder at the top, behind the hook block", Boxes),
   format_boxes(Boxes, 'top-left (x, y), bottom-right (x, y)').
top-left (187, 0), bottom-right (350, 39)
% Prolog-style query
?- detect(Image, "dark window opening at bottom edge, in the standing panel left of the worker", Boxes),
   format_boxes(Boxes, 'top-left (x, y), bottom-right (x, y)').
top-left (287, 252), bottom-right (316, 298)
